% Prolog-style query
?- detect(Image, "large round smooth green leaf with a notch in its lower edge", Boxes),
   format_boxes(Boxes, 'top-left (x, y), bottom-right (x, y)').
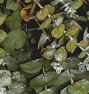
top-left (2, 30), bottom-right (26, 51)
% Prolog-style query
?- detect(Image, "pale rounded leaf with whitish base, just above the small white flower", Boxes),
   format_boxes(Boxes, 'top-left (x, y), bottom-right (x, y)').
top-left (54, 47), bottom-right (67, 61)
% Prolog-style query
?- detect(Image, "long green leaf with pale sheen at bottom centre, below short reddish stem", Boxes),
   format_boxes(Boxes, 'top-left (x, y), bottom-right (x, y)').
top-left (30, 71), bottom-right (58, 88)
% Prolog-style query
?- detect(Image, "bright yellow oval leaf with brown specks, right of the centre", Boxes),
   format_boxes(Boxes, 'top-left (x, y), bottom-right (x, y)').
top-left (51, 24), bottom-right (65, 39)
